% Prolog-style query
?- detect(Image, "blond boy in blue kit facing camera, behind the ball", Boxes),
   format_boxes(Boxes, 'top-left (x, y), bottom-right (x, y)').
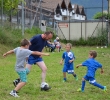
top-left (60, 43), bottom-right (78, 82)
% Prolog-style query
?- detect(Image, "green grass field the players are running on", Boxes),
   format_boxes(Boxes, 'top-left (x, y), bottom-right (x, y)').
top-left (0, 47), bottom-right (110, 100)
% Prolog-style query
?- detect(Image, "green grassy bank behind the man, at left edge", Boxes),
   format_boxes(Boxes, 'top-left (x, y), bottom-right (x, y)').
top-left (0, 27), bottom-right (42, 47)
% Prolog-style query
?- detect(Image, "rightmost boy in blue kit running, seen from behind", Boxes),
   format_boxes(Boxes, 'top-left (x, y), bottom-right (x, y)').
top-left (76, 50), bottom-right (107, 92)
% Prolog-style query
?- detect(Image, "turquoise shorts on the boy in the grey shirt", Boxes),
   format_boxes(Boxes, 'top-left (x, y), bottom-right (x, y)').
top-left (17, 68), bottom-right (29, 82)
